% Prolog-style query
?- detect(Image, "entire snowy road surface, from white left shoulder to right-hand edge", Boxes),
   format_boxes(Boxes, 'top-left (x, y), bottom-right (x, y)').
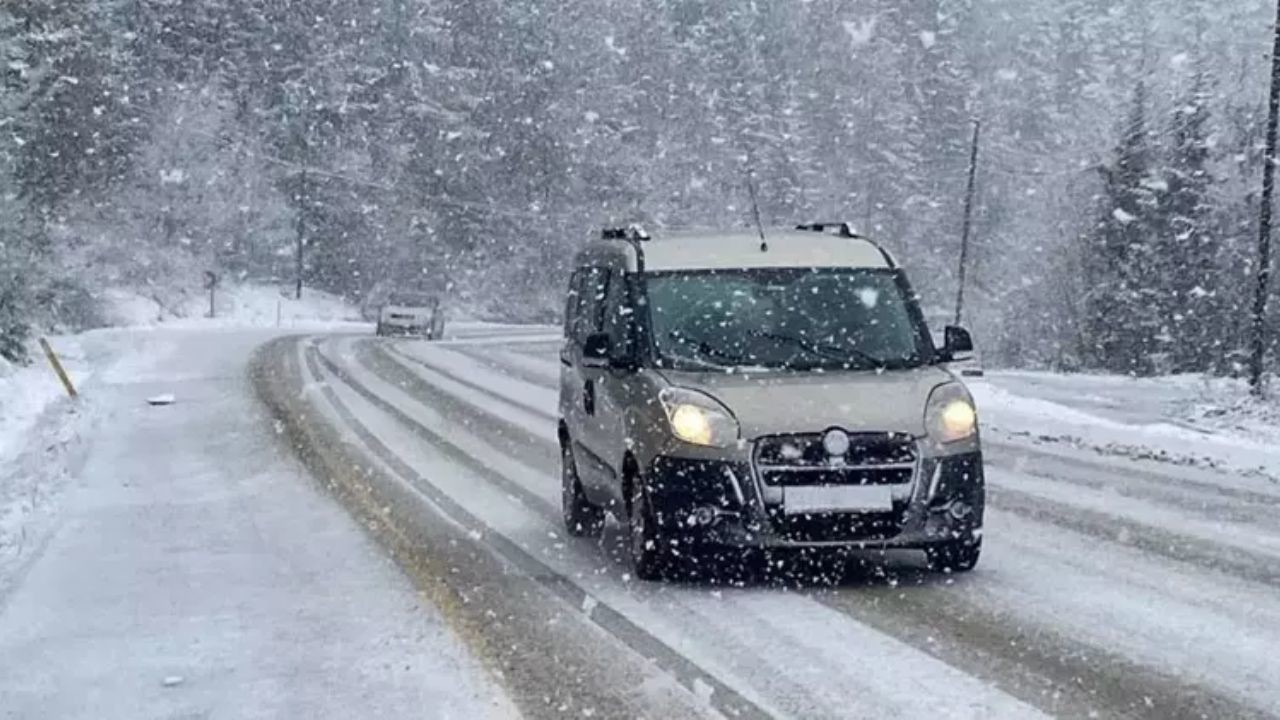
top-left (0, 325), bottom-right (1280, 720)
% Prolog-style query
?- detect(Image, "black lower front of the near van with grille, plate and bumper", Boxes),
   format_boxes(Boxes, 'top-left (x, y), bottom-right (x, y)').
top-left (643, 429), bottom-right (986, 559)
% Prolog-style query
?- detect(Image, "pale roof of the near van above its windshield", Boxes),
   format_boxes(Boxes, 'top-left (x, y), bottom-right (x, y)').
top-left (586, 229), bottom-right (895, 272)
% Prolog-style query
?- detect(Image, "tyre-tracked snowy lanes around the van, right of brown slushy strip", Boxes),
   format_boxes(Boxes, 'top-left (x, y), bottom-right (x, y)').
top-left (249, 331), bottom-right (1280, 719)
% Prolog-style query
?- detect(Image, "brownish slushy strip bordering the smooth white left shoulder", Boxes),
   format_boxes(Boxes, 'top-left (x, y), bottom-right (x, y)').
top-left (253, 340), bottom-right (719, 720)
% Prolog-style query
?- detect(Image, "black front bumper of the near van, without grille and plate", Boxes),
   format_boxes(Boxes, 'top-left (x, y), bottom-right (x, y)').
top-left (645, 452), bottom-right (986, 550)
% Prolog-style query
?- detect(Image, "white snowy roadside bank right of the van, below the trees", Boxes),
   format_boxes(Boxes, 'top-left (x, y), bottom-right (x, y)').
top-left (968, 372), bottom-right (1280, 482)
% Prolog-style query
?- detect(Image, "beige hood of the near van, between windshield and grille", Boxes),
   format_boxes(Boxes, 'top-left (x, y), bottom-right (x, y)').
top-left (664, 368), bottom-right (955, 439)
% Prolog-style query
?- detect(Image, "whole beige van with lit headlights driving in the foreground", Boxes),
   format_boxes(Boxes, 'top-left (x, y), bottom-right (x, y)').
top-left (559, 224), bottom-right (986, 579)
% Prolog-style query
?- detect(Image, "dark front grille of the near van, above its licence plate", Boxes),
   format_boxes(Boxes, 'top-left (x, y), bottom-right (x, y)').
top-left (755, 433), bottom-right (916, 487)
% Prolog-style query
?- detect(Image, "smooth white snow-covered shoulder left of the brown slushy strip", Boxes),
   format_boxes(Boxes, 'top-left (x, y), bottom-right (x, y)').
top-left (0, 331), bottom-right (515, 720)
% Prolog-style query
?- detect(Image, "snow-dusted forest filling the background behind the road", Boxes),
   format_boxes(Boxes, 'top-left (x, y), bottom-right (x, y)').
top-left (0, 0), bottom-right (1280, 374)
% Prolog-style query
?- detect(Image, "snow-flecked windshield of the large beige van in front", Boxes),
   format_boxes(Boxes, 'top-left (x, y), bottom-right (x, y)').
top-left (645, 269), bottom-right (933, 370)
